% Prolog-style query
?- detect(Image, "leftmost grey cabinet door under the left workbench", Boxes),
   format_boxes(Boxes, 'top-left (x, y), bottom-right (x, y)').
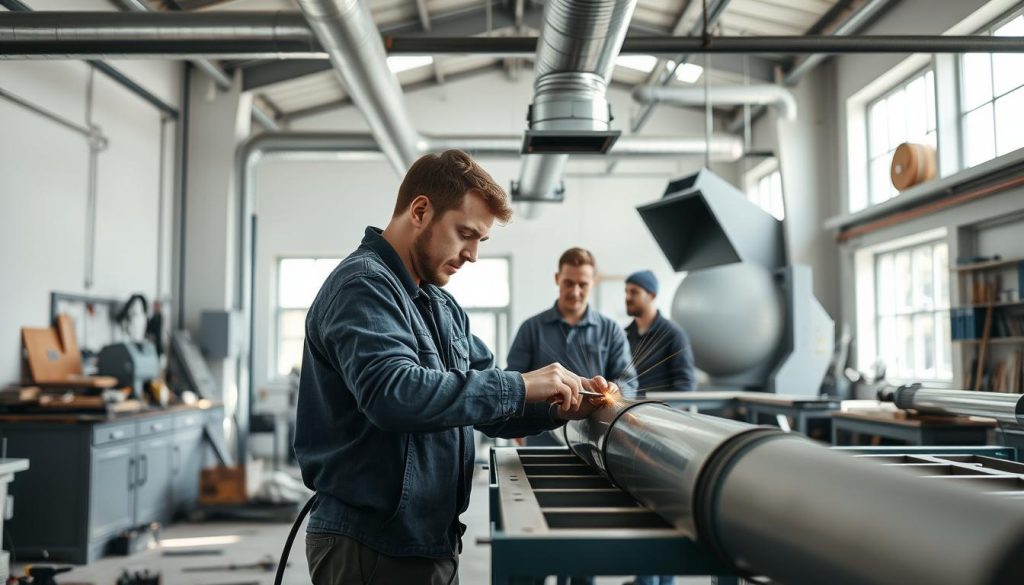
top-left (89, 441), bottom-right (136, 540)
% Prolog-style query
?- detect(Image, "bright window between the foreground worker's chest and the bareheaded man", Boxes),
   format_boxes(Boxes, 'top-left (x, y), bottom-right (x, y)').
top-left (444, 257), bottom-right (512, 365)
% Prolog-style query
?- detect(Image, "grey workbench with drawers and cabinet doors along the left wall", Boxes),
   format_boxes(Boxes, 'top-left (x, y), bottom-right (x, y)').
top-left (0, 405), bottom-right (224, 563)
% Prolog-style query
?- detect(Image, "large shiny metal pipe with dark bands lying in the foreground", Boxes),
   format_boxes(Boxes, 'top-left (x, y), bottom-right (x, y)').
top-left (564, 401), bottom-right (1024, 585)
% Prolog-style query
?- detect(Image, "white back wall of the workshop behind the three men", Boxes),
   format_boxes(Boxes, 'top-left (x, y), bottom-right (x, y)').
top-left (254, 71), bottom-right (732, 388)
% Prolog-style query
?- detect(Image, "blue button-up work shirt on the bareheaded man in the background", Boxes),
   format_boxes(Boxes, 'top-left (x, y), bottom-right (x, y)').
top-left (506, 302), bottom-right (637, 396)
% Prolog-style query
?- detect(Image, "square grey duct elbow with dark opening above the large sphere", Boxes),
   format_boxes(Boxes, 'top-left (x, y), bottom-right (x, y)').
top-left (637, 169), bottom-right (785, 271)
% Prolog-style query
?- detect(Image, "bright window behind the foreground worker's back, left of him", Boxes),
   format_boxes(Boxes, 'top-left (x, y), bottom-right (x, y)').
top-left (276, 258), bottom-right (341, 376)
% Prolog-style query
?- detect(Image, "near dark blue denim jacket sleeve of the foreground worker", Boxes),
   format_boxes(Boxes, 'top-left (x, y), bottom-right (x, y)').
top-left (316, 273), bottom-right (525, 432)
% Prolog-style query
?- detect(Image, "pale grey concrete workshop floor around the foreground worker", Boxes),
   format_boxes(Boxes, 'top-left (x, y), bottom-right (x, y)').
top-left (19, 467), bottom-right (711, 585)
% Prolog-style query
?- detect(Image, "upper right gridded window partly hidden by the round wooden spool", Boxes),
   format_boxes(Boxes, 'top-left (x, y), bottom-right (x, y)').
top-left (867, 69), bottom-right (936, 205)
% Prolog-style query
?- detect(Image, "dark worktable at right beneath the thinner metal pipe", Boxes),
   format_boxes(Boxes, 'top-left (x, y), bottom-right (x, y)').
top-left (831, 411), bottom-right (995, 445)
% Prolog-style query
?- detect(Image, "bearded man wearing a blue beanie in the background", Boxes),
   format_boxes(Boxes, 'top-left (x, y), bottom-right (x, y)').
top-left (626, 270), bottom-right (696, 391)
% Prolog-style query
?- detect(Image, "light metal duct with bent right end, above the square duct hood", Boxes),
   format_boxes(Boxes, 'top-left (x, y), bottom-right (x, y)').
top-left (633, 84), bottom-right (797, 122)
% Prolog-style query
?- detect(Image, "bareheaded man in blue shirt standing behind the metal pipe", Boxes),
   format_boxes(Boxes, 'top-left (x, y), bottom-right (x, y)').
top-left (508, 248), bottom-right (637, 585)
